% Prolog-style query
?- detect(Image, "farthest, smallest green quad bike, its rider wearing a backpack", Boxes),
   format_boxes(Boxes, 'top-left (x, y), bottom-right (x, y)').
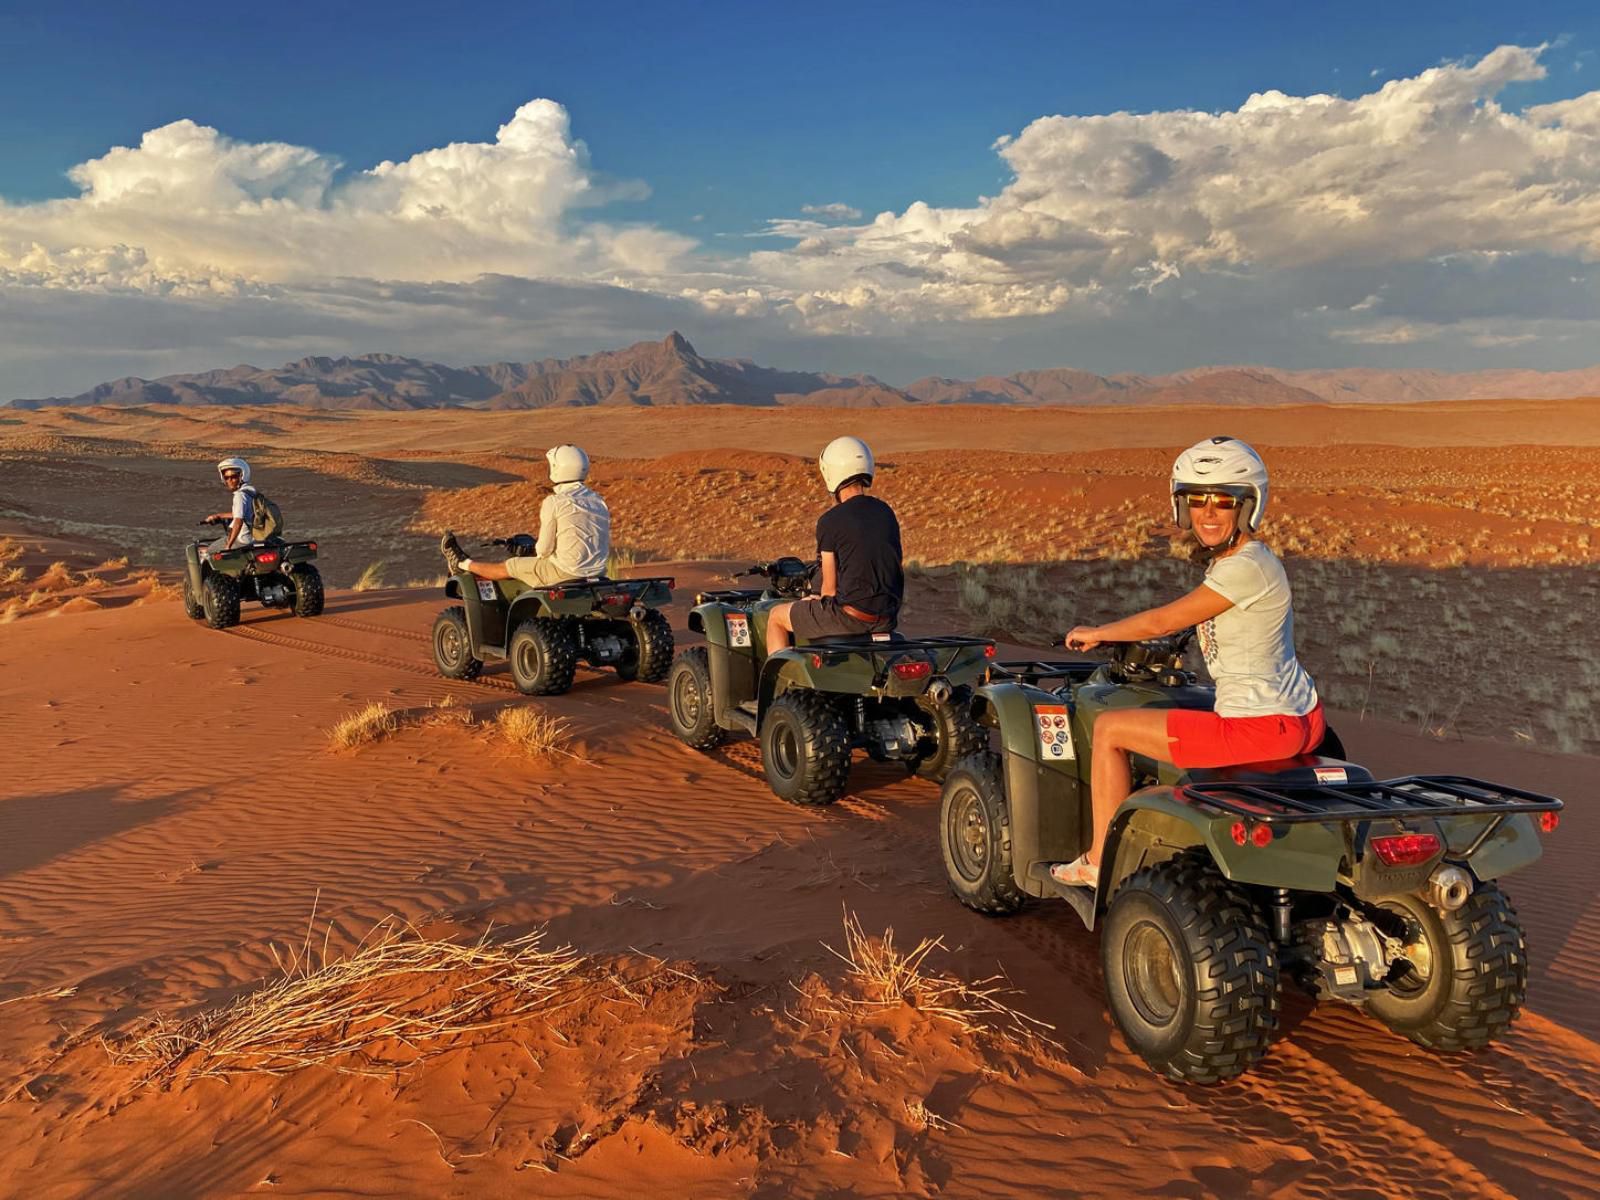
top-left (184, 518), bottom-right (323, 629)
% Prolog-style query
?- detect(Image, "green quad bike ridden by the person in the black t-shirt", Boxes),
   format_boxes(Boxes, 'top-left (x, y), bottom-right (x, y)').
top-left (667, 558), bottom-right (995, 805)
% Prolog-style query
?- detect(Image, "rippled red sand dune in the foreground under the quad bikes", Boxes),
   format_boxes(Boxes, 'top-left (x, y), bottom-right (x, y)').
top-left (0, 565), bottom-right (1600, 1198)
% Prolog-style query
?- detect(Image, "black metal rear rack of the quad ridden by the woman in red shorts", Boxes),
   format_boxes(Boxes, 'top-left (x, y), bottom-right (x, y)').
top-left (1179, 774), bottom-right (1562, 850)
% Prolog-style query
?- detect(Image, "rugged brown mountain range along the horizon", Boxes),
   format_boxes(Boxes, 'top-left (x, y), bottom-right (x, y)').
top-left (11, 333), bottom-right (1600, 410)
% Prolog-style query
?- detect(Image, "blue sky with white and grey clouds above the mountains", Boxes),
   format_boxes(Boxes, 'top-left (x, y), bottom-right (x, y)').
top-left (0, 3), bottom-right (1600, 398)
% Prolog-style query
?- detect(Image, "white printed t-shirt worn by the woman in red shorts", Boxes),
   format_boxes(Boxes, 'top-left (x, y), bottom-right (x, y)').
top-left (1197, 541), bottom-right (1317, 717)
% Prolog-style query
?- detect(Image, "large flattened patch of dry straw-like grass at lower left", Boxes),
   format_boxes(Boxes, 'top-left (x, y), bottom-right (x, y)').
top-left (104, 909), bottom-right (582, 1083)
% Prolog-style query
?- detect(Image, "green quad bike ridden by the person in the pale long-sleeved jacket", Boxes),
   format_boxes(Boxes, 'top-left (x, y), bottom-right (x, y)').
top-left (434, 533), bottom-right (675, 696)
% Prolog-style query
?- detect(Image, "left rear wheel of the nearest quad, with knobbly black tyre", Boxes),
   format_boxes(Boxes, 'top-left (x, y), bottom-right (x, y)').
top-left (1101, 851), bottom-right (1278, 1083)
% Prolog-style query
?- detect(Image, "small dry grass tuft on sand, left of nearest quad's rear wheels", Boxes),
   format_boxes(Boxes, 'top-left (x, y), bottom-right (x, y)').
top-left (798, 910), bottom-right (1053, 1045)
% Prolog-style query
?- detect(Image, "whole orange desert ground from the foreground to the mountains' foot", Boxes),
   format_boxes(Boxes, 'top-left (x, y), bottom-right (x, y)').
top-left (0, 400), bottom-right (1600, 1200)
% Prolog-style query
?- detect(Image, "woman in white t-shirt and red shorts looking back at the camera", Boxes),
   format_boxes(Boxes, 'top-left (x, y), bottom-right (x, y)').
top-left (1051, 437), bottom-right (1326, 886)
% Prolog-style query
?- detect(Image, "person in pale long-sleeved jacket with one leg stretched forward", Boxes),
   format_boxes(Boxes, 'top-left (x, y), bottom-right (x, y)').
top-left (438, 446), bottom-right (611, 587)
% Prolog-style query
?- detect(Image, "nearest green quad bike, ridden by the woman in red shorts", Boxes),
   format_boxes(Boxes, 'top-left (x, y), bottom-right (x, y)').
top-left (939, 637), bottom-right (1562, 1083)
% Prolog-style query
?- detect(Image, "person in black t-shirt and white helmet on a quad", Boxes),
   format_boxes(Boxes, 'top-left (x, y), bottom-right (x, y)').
top-left (766, 437), bottom-right (906, 654)
